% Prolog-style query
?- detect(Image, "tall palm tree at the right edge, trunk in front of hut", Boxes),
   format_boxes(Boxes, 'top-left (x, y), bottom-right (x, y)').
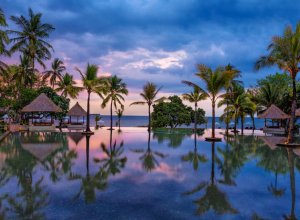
top-left (255, 22), bottom-right (300, 143)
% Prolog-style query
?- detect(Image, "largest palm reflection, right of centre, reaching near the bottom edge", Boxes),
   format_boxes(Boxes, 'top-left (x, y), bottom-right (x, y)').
top-left (184, 142), bottom-right (238, 215)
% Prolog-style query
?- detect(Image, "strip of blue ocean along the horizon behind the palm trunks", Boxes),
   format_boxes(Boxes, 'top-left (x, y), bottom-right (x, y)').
top-left (86, 115), bottom-right (264, 129)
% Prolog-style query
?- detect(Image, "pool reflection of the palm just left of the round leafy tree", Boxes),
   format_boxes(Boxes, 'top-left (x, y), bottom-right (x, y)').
top-left (132, 131), bottom-right (167, 172)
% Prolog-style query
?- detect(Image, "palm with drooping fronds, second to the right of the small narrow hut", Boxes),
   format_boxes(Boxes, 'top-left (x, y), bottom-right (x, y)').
top-left (101, 76), bottom-right (128, 130)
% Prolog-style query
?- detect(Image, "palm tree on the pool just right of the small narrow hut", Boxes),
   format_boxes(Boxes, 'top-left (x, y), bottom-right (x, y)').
top-left (76, 64), bottom-right (103, 133)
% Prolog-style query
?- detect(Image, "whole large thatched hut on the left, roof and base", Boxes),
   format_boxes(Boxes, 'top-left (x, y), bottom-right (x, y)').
top-left (22, 93), bottom-right (62, 131)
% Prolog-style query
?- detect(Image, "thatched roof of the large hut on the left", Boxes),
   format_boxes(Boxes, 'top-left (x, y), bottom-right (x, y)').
top-left (22, 93), bottom-right (62, 113)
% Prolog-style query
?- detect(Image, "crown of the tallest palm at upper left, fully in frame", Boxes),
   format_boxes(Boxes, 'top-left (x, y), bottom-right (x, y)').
top-left (7, 9), bottom-right (54, 69)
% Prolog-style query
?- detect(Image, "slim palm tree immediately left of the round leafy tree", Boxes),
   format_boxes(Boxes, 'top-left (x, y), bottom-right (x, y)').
top-left (130, 82), bottom-right (163, 131)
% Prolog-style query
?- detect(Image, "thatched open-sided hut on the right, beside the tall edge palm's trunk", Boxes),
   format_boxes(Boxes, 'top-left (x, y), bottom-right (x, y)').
top-left (258, 105), bottom-right (290, 134)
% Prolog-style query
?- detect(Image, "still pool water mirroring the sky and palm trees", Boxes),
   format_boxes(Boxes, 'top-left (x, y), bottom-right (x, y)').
top-left (0, 128), bottom-right (300, 219)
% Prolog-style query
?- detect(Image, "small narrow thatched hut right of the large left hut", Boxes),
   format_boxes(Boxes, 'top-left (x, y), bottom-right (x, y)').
top-left (68, 102), bottom-right (87, 129)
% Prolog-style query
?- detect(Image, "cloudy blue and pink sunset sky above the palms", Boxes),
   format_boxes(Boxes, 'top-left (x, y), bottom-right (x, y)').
top-left (0, 0), bottom-right (300, 116)
